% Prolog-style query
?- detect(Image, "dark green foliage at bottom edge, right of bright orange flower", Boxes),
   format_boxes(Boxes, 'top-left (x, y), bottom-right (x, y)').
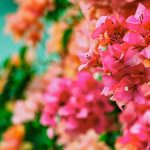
top-left (25, 116), bottom-right (62, 150)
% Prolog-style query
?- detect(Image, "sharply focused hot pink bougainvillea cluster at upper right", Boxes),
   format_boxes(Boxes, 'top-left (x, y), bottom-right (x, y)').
top-left (80, 4), bottom-right (150, 108)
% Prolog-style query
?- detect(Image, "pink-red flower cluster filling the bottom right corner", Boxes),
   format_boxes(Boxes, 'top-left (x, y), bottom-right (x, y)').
top-left (116, 99), bottom-right (150, 150)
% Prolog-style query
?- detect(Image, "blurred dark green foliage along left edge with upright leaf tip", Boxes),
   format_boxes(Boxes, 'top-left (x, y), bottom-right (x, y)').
top-left (0, 47), bottom-right (34, 138)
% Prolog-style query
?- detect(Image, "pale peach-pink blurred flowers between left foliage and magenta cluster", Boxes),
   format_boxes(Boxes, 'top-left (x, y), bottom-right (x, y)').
top-left (12, 68), bottom-right (56, 124)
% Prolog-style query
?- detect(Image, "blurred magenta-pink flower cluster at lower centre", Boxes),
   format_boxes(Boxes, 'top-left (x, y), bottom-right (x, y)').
top-left (41, 72), bottom-right (113, 134)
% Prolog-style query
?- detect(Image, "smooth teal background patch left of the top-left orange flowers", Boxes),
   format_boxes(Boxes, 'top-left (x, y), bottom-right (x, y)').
top-left (0, 0), bottom-right (21, 63)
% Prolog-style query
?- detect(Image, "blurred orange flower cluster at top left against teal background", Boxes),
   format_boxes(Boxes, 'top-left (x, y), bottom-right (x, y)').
top-left (6, 0), bottom-right (54, 45)
